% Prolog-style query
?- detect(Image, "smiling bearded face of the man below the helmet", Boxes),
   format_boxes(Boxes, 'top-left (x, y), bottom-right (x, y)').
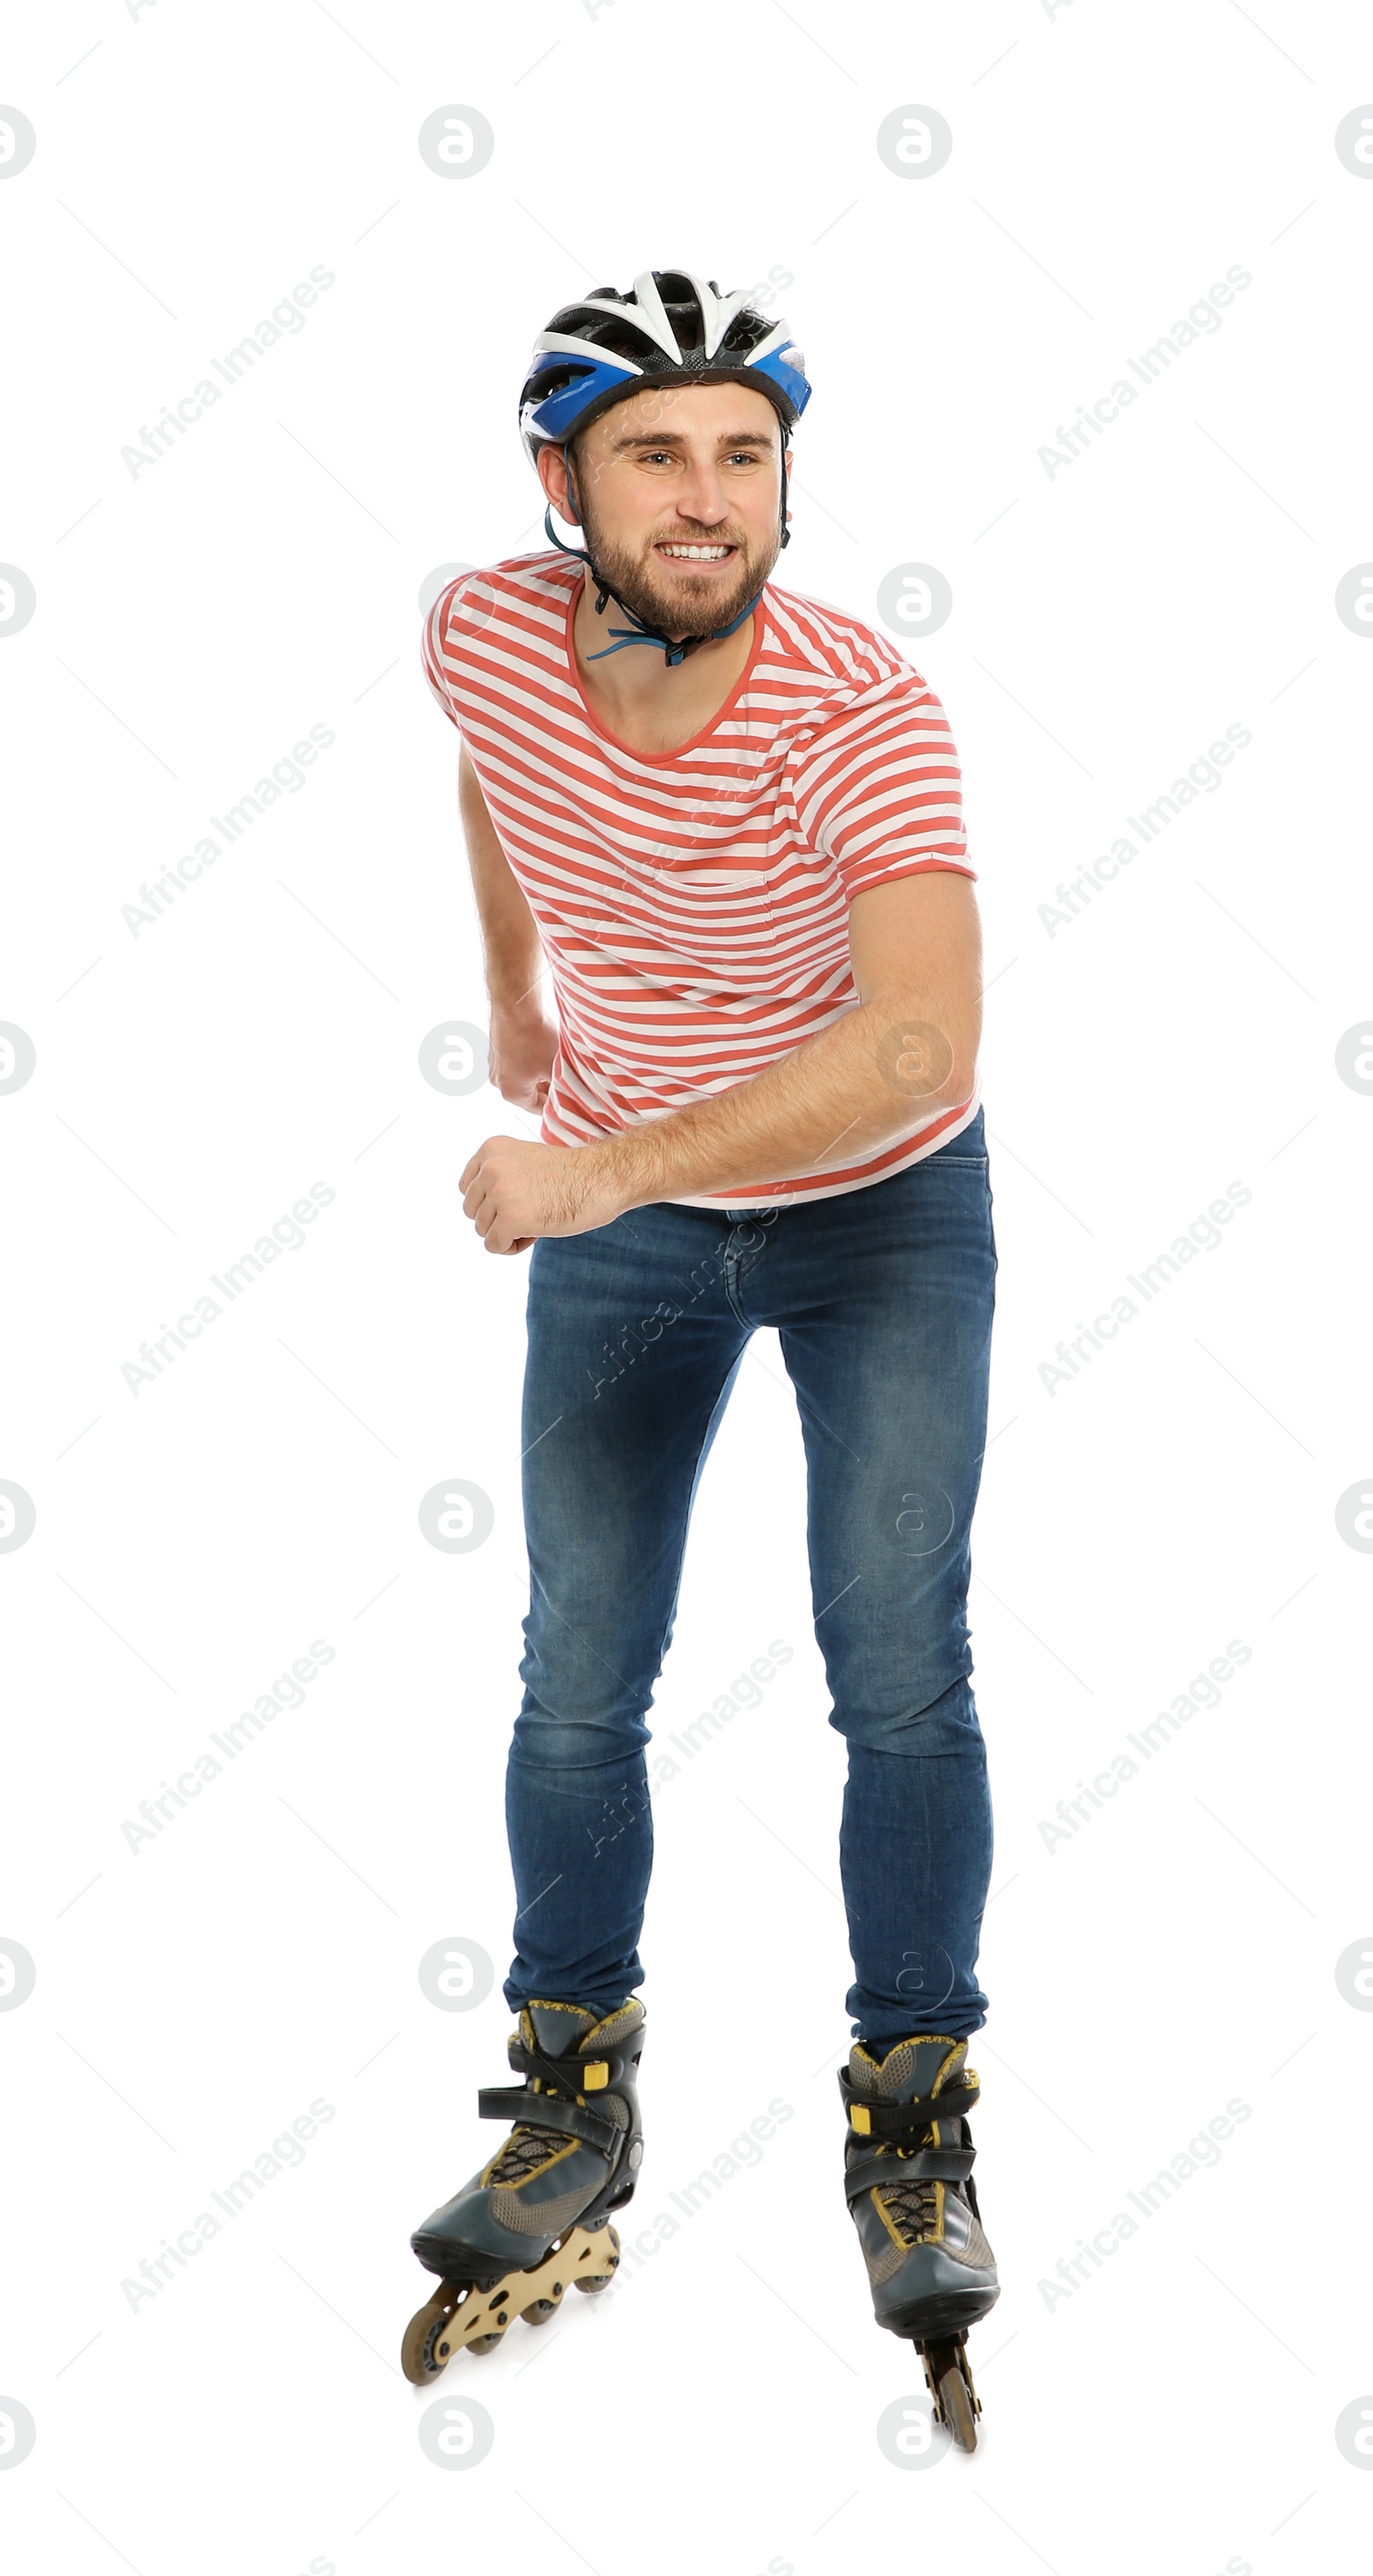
top-left (538, 384), bottom-right (783, 641)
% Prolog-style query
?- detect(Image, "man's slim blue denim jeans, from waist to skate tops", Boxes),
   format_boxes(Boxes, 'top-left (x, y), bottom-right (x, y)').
top-left (505, 1110), bottom-right (997, 2041)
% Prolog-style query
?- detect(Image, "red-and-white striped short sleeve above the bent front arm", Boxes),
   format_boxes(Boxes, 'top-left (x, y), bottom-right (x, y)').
top-left (794, 673), bottom-right (977, 902)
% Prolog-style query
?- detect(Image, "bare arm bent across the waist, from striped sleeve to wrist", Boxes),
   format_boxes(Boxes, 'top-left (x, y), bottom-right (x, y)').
top-left (577, 868), bottom-right (982, 1211)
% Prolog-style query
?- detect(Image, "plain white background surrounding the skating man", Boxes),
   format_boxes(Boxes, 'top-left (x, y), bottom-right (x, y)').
top-left (0, 0), bottom-right (1373, 2576)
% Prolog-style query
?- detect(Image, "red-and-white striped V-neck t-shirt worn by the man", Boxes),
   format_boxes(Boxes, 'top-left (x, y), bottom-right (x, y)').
top-left (422, 553), bottom-right (979, 1208)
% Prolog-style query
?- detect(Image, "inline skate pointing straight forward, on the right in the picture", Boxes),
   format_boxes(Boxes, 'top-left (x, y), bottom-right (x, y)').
top-left (840, 2030), bottom-right (1002, 2450)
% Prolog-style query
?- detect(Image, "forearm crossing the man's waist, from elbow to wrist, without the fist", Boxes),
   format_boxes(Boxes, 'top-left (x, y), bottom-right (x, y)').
top-left (577, 995), bottom-right (977, 1208)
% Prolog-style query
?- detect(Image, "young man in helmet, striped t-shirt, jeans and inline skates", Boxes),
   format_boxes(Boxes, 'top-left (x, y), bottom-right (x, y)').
top-left (404, 270), bottom-right (997, 2447)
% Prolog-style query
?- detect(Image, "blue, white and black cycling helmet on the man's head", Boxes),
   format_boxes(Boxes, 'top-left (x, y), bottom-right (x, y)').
top-left (520, 268), bottom-right (812, 463)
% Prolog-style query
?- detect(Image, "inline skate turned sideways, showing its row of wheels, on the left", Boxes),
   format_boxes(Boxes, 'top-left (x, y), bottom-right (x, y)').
top-left (399, 1997), bottom-right (644, 2388)
